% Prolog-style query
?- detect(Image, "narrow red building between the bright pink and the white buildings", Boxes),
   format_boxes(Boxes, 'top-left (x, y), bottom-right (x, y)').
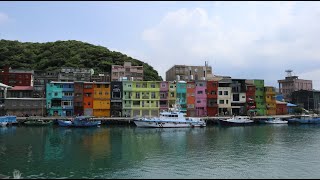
top-left (207, 80), bottom-right (219, 116)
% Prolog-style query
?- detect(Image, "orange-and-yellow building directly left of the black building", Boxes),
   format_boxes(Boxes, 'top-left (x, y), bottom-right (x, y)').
top-left (93, 82), bottom-right (110, 117)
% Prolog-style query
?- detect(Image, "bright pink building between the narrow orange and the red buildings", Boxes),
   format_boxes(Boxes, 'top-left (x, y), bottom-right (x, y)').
top-left (195, 80), bottom-right (207, 117)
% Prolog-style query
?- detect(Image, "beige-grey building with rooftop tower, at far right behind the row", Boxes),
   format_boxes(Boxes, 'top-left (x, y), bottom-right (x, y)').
top-left (278, 70), bottom-right (312, 102)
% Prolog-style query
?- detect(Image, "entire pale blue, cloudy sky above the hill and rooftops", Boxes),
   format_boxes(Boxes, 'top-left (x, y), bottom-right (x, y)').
top-left (0, 1), bottom-right (320, 90)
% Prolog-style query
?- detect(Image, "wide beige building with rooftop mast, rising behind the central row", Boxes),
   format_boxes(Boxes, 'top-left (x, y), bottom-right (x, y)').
top-left (166, 62), bottom-right (213, 81)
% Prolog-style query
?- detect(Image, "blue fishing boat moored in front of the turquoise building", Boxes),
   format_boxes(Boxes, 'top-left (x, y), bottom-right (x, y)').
top-left (58, 116), bottom-right (101, 127)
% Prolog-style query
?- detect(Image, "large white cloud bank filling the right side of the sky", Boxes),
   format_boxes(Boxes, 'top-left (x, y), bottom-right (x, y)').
top-left (142, 2), bottom-right (320, 88)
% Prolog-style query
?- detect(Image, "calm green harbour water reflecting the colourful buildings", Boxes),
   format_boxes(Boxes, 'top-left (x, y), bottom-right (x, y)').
top-left (0, 125), bottom-right (320, 179)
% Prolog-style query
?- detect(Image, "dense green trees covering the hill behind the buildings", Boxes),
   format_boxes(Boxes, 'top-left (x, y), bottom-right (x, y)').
top-left (0, 40), bottom-right (162, 81)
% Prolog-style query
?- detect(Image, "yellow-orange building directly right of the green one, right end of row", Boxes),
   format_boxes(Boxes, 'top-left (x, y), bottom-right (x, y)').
top-left (264, 86), bottom-right (277, 115)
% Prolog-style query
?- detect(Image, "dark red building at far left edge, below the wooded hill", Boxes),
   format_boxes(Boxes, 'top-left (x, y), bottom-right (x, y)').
top-left (0, 66), bottom-right (33, 86)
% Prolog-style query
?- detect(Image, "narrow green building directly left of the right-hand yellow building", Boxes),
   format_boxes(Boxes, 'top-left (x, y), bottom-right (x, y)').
top-left (253, 79), bottom-right (267, 116)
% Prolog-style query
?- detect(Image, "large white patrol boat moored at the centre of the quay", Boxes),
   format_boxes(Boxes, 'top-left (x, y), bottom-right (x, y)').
top-left (133, 102), bottom-right (206, 128)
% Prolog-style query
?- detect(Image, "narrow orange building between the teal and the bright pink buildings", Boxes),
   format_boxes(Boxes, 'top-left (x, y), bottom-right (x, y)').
top-left (187, 81), bottom-right (197, 117)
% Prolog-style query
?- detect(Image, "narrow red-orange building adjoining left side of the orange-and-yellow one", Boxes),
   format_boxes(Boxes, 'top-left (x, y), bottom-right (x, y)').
top-left (83, 82), bottom-right (94, 116)
